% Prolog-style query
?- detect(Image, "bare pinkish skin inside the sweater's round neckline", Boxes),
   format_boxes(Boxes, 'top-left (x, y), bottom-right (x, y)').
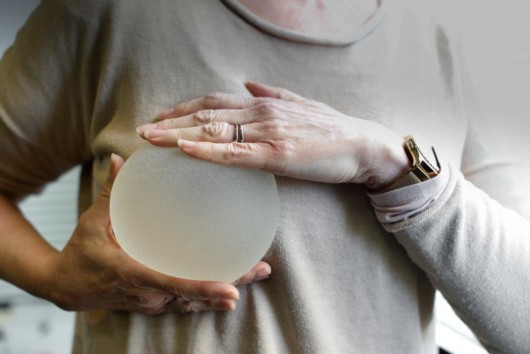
top-left (234, 0), bottom-right (378, 35)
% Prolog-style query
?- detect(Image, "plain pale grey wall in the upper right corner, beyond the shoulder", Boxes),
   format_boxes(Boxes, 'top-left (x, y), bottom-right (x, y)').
top-left (438, 0), bottom-right (530, 165)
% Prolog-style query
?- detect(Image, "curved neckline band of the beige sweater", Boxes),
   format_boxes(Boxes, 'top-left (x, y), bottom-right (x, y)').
top-left (221, 0), bottom-right (388, 46)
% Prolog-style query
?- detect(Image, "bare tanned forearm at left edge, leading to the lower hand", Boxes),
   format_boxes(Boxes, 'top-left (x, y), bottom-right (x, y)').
top-left (0, 195), bottom-right (58, 298)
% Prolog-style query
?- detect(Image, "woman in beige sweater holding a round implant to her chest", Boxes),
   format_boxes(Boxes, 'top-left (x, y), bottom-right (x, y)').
top-left (0, 0), bottom-right (530, 353)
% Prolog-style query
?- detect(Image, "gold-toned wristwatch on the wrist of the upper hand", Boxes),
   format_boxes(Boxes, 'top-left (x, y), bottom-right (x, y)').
top-left (384, 135), bottom-right (441, 192)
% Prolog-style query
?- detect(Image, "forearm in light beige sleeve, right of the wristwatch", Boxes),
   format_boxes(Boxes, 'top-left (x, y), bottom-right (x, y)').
top-left (385, 167), bottom-right (530, 353)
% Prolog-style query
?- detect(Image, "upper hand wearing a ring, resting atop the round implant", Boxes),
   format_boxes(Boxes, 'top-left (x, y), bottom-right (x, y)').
top-left (138, 83), bottom-right (409, 189)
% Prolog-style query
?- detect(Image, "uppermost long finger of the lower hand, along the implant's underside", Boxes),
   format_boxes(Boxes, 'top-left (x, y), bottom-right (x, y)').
top-left (133, 263), bottom-right (239, 300)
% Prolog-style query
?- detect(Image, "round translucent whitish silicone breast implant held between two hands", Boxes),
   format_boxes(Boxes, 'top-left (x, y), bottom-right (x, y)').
top-left (110, 145), bottom-right (280, 282)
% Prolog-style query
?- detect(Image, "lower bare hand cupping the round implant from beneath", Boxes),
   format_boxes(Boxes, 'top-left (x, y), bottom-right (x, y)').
top-left (45, 155), bottom-right (271, 314)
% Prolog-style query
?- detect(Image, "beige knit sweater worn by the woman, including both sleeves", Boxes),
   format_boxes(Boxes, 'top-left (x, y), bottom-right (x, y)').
top-left (0, 0), bottom-right (530, 353)
